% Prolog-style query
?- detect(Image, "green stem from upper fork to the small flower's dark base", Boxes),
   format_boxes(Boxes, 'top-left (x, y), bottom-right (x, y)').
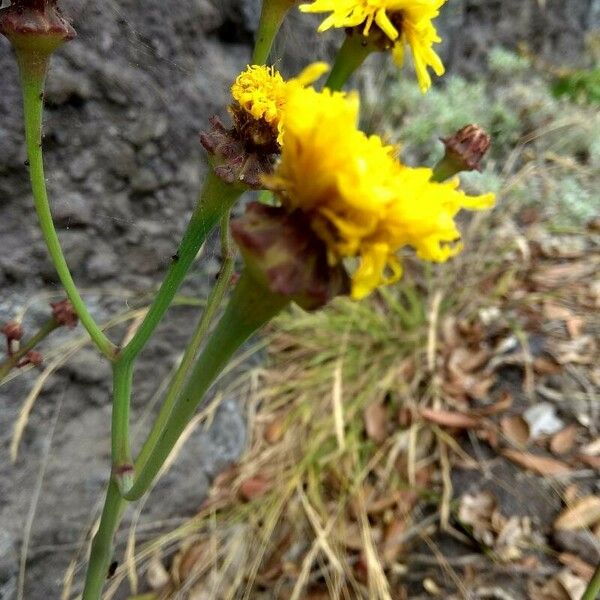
top-left (119, 169), bottom-right (243, 362)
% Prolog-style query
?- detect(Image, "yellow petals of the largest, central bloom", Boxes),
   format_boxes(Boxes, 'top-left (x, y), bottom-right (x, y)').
top-left (264, 88), bottom-right (494, 299)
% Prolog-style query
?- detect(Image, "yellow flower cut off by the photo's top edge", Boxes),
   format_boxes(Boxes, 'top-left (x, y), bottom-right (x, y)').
top-left (300, 0), bottom-right (446, 92)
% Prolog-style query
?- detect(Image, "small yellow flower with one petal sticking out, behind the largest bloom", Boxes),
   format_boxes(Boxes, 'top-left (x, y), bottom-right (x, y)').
top-left (231, 62), bottom-right (329, 143)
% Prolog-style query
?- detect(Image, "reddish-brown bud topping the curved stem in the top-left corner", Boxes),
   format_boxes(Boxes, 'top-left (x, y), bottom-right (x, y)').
top-left (0, 0), bottom-right (76, 57)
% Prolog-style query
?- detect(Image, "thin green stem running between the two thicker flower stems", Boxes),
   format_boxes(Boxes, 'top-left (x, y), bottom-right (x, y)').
top-left (130, 214), bottom-right (234, 478)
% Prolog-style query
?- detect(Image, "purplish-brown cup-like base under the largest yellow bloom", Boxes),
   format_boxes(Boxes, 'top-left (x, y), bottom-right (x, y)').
top-left (231, 202), bottom-right (350, 310)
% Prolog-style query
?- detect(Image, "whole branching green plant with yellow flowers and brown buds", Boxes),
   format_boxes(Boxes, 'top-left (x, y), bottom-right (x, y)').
top-left (0, 0), bottom-right (508, 600)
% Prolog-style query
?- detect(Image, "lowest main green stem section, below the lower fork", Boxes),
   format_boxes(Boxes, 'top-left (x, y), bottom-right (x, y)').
top-left (82, 480), bottom-right (127, 600)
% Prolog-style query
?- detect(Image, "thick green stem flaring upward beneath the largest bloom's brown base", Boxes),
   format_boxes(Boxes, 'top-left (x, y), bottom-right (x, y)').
top-left (124, 274), bottom-right (289, 500)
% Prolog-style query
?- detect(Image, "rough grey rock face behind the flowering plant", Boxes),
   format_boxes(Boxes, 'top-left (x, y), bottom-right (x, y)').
top-left (0, 0), bottom-right (600, 600)
